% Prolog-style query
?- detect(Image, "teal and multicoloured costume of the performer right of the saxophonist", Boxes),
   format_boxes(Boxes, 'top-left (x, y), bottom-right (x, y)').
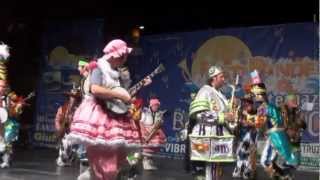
top-left (252, 83), bottom-right (299, 179)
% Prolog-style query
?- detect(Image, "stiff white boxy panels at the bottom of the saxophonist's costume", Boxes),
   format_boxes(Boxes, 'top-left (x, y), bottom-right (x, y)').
top-left (189, 134), bottom-right (236, 162)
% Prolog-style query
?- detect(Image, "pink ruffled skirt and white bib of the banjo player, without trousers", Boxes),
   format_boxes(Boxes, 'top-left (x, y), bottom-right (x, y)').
top-left (69, 58), bottom-right (140, 148)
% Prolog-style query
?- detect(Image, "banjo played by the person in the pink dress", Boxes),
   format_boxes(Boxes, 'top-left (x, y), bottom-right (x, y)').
top-left (105, 64), bottom-right (165, 115)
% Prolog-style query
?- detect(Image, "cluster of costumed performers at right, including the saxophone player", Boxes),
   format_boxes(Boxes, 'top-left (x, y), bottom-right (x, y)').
top-left (187, 66), bottom-right (306, 180)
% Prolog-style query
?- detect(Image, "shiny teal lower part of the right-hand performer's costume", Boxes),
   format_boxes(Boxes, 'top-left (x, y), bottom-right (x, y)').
top-left (269, 130), bottom-right (299, 166)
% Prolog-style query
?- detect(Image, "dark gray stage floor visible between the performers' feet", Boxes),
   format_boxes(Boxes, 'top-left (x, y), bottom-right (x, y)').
top-left (0, 149), bottom-right (319, 180)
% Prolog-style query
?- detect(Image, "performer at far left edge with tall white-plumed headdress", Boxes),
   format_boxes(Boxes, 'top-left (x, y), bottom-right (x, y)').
top-left (0, 44), bottom-right (34, 168)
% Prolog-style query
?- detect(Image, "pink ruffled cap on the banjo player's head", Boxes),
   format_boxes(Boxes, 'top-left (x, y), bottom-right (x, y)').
top-left (103, 39), bottom-right (132, 59)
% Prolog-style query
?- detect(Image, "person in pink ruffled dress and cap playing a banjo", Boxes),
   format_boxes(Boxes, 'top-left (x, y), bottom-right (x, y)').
top-left (68, 39), bottom-right (141, 180)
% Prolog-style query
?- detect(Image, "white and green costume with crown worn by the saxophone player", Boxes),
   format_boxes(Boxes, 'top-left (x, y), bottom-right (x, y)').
top-left (189, 66), bottom-right (235, 180)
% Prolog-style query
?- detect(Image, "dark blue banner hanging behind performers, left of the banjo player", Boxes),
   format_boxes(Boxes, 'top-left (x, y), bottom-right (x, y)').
top-left (31, 20), bottom-right (103, 147)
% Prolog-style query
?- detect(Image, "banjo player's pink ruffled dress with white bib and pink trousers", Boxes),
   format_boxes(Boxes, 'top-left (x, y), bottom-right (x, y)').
top-left (68, 58), bottom-right (141, 180)
